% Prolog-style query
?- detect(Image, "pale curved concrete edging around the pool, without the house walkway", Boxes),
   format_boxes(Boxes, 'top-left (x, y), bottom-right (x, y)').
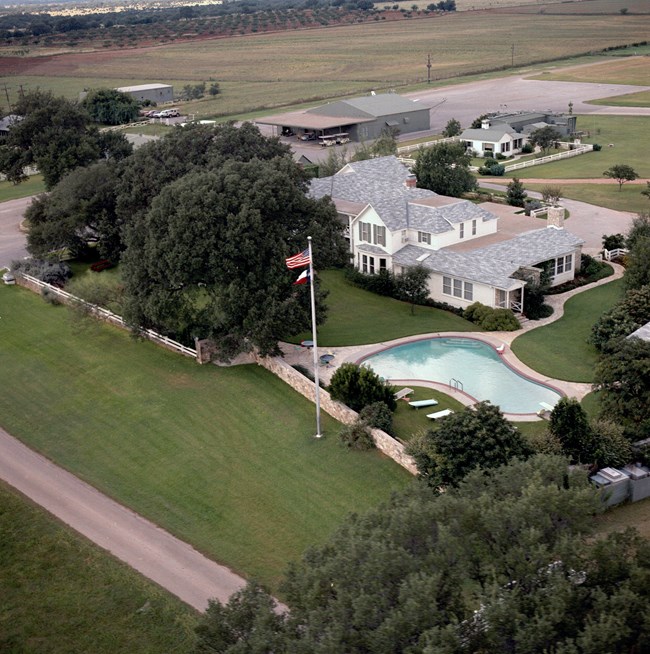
top-left (347, 332), bottom-right (591, 422)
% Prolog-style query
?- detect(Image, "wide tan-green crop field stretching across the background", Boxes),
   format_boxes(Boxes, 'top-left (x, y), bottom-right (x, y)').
top-left (0, 3), bottom-right (650, 116)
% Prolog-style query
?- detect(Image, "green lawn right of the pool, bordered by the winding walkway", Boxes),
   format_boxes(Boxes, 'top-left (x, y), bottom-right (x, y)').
top-left (512, 280), bottom-right (622, 382)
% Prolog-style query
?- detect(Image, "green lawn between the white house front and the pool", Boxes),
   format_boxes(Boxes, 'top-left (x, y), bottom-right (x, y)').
top-left (291, 270), bottom-right (481, 347)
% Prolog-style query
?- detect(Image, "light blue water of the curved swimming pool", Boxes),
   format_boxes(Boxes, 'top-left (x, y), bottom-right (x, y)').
top-left (362, 338), bottom-right (562, 413)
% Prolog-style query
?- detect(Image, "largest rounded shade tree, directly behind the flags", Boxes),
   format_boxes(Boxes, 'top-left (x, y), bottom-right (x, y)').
top-left (123, 157), bottom-right (346, 358)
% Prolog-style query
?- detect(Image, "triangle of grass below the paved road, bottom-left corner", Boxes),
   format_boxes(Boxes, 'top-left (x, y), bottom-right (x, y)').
top-left (0, 483), bottom-right (197, 654)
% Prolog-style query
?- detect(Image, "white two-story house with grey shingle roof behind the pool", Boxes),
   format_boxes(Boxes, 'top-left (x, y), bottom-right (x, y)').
top-left (310, 156), bottom-right (583, 312)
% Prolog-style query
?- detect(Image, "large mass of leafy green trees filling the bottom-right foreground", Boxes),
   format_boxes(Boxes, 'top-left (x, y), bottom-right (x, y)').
top-left (196, 456), bottom-right (650, 654)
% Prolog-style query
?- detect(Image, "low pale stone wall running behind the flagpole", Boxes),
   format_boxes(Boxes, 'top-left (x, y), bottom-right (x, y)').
top-left (255, 355), bottom-right (417, 475)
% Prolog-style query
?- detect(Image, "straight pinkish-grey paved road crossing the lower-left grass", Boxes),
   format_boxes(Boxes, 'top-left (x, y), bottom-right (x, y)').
top-left (0, 428), bottom-right (246, 611)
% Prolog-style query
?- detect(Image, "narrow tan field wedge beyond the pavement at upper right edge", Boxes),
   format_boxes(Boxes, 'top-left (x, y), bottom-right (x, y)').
top-left (533, 56), bottom-right (650, 86)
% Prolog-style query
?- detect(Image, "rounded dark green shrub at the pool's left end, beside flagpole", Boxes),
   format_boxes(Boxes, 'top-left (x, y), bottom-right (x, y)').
top-left (329, 363), bottom-right (397, 411)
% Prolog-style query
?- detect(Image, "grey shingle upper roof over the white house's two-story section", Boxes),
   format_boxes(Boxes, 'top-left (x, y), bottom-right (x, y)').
top-left (310, 156), bottom-right (496, 234)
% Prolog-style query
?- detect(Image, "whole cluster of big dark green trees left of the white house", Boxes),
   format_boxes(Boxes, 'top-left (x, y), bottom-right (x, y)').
top-left (0, 92), bottom-right (346, 358)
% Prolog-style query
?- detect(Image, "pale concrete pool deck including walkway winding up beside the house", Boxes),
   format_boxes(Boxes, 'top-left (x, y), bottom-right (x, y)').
top-left (281, 264), bottom-right (624, 422)
